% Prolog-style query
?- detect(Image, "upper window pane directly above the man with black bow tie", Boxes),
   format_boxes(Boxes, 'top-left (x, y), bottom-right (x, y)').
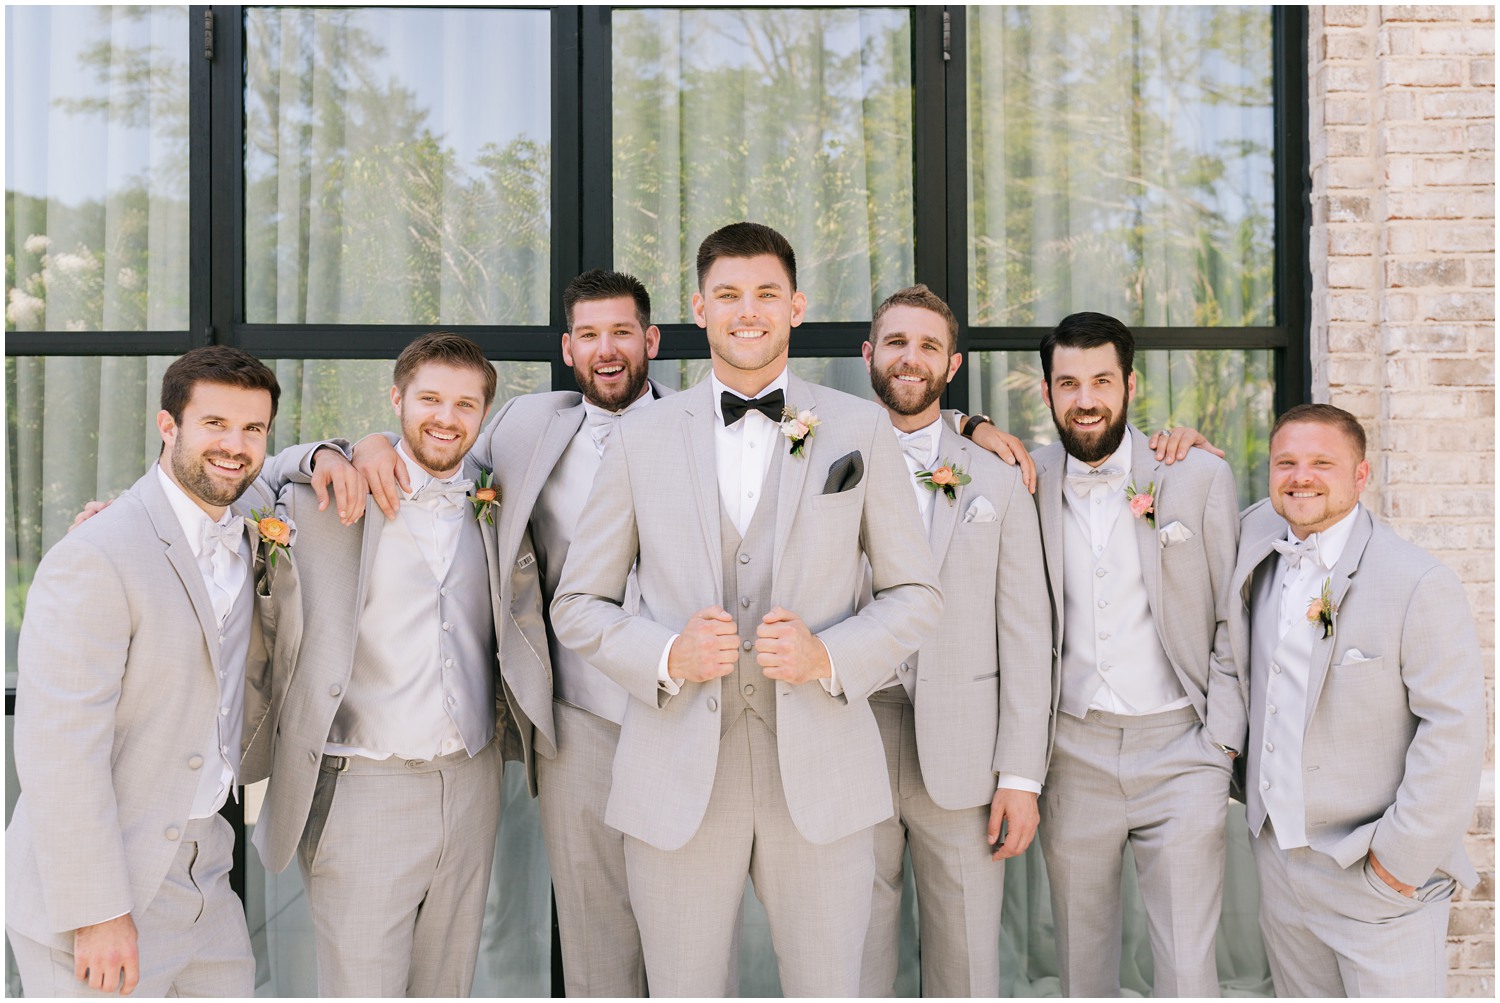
top-left (612, 9), bottom-right (914, 324)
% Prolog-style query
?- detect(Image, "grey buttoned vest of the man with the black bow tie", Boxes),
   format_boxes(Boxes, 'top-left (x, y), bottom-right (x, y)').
top-left (719, 450), bottom-right (785, 738)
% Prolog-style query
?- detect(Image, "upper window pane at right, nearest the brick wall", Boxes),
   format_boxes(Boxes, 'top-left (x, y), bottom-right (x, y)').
top-left (966, 6), bottom-right (1275, 327)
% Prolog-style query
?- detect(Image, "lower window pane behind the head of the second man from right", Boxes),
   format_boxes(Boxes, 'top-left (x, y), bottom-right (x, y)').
top-left (959, 349), bottom-right (1275, 508)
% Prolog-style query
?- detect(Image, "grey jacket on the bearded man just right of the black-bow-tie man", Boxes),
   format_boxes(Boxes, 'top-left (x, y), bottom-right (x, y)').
top-left (896, 423), bottom-right (1052, 810)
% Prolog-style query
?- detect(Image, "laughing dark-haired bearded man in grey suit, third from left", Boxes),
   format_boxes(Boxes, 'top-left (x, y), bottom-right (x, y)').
top-left (354, 268), bottom-right (669, 997)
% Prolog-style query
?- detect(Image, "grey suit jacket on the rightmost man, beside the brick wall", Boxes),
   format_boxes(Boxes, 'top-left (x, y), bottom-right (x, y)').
top-left (1235, 499), bottom-right (1485, 888)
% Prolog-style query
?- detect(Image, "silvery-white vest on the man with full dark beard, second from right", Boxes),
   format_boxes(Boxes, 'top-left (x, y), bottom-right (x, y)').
top-left (1061, 495), bottom-right (1187, 718)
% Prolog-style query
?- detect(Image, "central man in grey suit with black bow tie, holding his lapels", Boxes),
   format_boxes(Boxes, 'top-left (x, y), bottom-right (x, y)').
top-left (552, 223), bottom-right (941, 996)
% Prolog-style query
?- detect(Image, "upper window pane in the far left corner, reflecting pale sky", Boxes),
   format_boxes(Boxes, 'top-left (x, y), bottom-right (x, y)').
top-left (5, 6), bottom-right (189, 331)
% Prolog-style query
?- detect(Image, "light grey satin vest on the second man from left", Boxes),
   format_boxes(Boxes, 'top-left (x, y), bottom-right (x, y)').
top-left (329, 517), bottom-right (495, 749)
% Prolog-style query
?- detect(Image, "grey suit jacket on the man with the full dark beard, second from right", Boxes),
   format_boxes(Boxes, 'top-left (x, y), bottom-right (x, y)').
top-left (1032, 426), bottom-right (1250, 760)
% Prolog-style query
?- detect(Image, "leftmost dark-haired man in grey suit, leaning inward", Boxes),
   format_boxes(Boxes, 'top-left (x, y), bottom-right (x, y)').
top-left (6, 346), bottom-right (281, 996)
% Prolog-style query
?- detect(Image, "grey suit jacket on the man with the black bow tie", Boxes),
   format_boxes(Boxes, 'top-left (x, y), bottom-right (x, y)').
top-left (552, 375), bottom-right (942, 850)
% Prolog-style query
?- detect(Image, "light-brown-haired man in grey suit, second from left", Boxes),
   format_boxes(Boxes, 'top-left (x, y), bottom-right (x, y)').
top-left (255, 333), bottom-right (555, 996)
